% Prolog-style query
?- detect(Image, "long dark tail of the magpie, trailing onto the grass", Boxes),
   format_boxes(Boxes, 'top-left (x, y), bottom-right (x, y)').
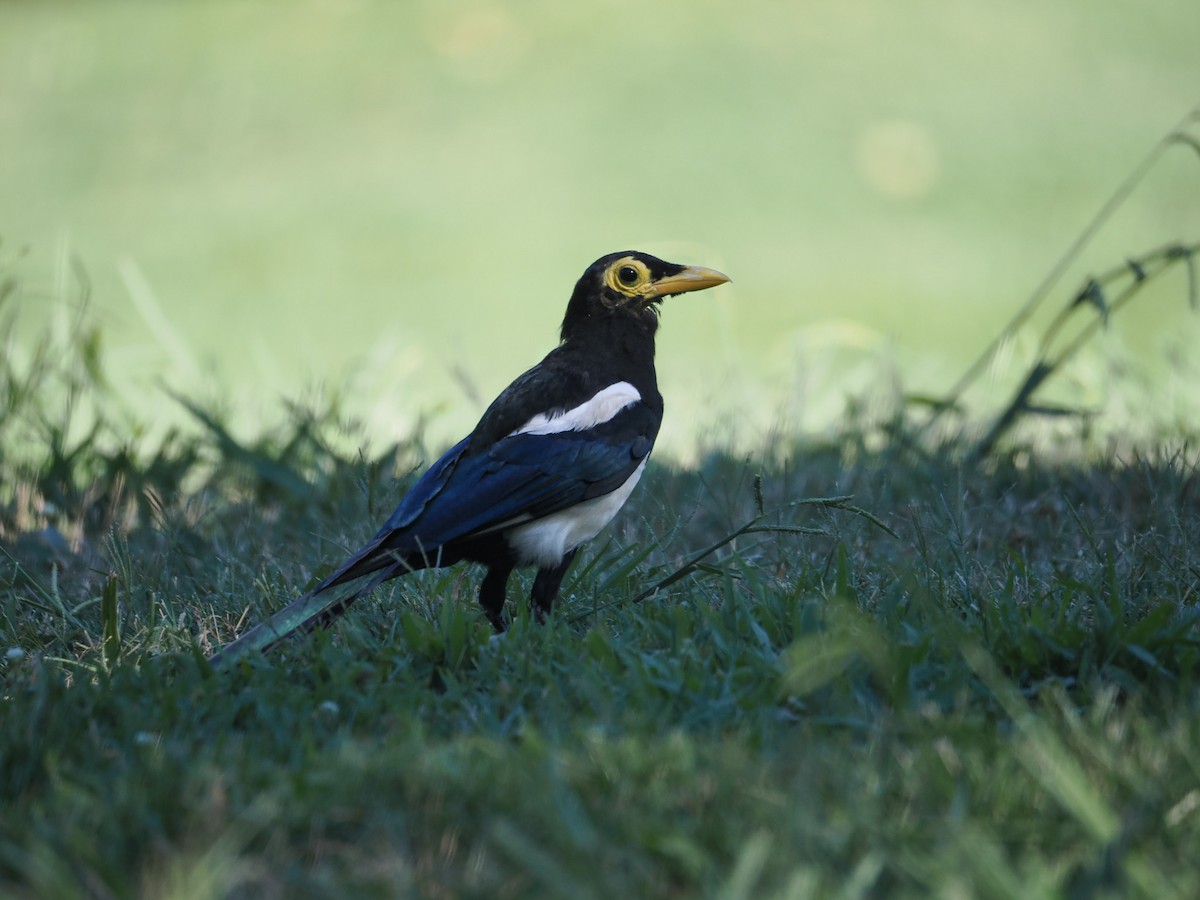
top-left (209, 533), bottom-right (428, 668)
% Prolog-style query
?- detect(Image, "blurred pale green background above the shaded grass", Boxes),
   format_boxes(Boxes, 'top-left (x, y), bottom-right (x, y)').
top-left (0, 0), bottom-right (1200, 455)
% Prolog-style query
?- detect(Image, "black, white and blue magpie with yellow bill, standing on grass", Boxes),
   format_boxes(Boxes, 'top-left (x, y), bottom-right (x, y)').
top-left (210, 251), bottom-right (730, 667)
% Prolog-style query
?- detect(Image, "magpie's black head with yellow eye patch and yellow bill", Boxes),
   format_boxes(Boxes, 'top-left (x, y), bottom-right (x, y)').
top-left (563, 250), bottom-right (730, 341)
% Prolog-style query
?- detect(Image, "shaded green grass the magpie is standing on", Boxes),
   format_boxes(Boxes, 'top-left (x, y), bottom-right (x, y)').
top-left (0, 285), bottom-right (1200, 898)
